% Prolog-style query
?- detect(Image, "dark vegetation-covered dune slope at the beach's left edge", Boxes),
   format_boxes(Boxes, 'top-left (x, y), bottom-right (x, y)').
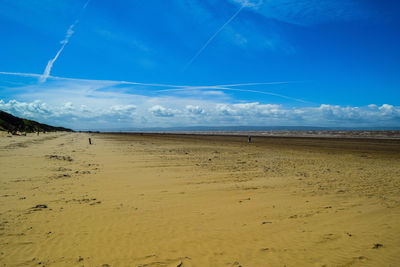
top-left (0, 110), bottom-right (72, 133)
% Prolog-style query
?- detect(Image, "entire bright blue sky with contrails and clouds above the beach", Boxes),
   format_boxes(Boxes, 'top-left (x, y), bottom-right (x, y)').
top-left (0, 0), bottom-right (400, 129)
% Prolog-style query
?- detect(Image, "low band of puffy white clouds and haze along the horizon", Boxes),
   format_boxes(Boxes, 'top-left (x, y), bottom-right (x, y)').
top-left (0, 99), bottom-right (400, 130)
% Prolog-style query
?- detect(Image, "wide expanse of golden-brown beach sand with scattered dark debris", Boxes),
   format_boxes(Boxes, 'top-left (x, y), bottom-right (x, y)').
top-left (0, 133), bottom-right (400, 267)
